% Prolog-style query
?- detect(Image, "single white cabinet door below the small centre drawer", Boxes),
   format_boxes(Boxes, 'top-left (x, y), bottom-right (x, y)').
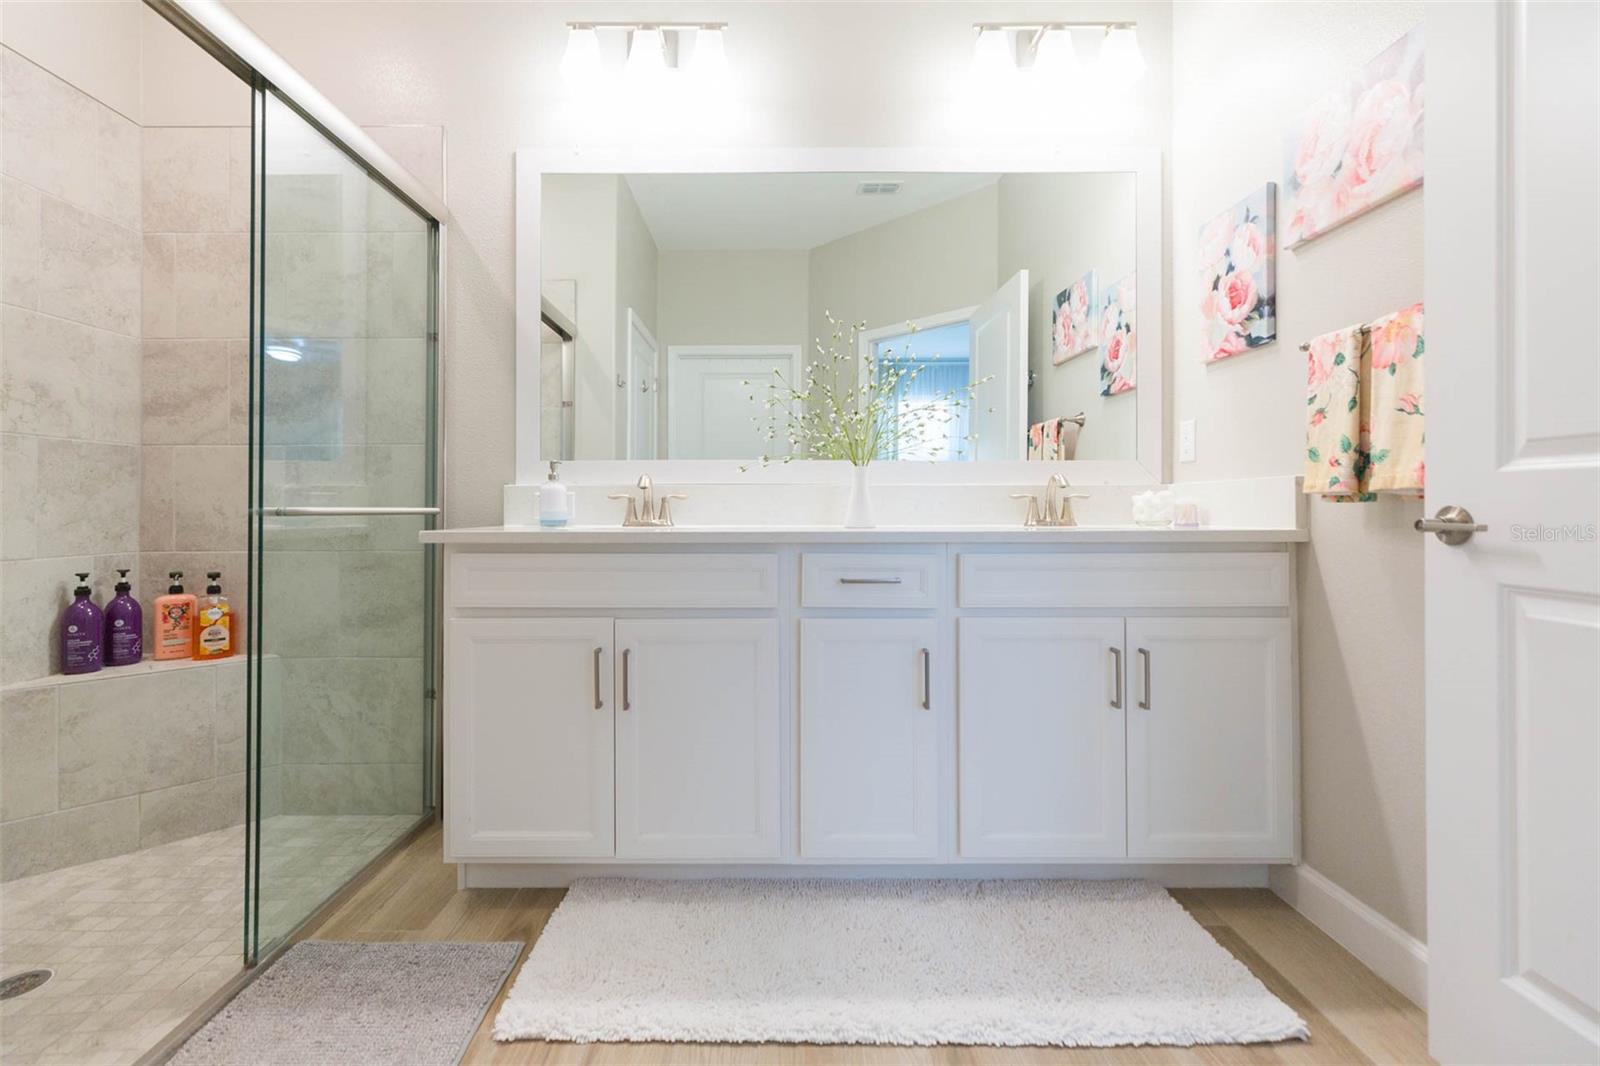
top-left (800, 618), bottom-right (939, 858)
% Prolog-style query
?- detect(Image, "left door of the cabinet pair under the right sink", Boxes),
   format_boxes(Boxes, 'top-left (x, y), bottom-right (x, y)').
top-left (958, 618), bottom-right (1126, 860)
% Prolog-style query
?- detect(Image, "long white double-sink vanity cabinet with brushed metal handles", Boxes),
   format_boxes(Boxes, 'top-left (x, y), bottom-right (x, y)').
top-left (429, 528), bottom-right (1298, 885)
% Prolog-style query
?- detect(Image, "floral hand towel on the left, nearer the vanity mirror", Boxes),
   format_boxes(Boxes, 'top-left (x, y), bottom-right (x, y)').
top-left (1306, 325), bottom-right (1366, 499)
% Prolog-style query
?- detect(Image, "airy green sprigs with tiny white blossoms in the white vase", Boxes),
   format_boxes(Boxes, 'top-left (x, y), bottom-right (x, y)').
top-left (739, 312), bottom-right (989, 471)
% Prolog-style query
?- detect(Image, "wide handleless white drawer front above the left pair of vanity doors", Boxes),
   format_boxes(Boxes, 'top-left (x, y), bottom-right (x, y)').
top-left (448, 552), bottom-right (778, 608)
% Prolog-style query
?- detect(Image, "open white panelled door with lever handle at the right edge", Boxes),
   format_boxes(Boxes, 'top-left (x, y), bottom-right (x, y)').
top-left (1419, 2), bottom-right (1600, 1063)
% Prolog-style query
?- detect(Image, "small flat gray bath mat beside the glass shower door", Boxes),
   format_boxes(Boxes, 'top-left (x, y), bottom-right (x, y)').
top-left (171, 940), bottom-right (522, 1066)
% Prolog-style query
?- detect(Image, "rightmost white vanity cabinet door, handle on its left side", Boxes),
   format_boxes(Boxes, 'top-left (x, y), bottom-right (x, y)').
top-left (1126, 618), bottom-right (1294, 860)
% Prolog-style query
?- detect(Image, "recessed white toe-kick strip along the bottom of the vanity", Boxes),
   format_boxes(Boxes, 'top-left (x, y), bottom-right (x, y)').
top-left (458, 863), bottom-right (1267, 888)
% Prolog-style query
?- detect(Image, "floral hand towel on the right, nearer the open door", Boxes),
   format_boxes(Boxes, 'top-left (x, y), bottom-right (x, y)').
top-left (1365, 304), bottom-right (1424, 496)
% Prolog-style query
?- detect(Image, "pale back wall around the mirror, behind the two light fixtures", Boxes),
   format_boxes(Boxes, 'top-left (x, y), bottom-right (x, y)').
top-left (229, 0), bottom-right (1171, 525)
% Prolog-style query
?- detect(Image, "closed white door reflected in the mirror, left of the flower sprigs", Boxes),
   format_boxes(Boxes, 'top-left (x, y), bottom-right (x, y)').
top-left (666, 344), bottom-right (800, 463)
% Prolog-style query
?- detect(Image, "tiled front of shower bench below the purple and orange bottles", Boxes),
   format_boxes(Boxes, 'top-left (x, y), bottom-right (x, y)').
top-left (0, 659), bottom-right (268, 880)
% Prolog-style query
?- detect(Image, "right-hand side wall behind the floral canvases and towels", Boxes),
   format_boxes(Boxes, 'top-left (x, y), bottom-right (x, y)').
top-left (1170, 3), bottom-right (1427, 938)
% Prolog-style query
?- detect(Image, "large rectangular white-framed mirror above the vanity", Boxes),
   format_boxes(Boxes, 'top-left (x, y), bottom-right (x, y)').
top-left (517, 149), bottom-right (1166, 485)
